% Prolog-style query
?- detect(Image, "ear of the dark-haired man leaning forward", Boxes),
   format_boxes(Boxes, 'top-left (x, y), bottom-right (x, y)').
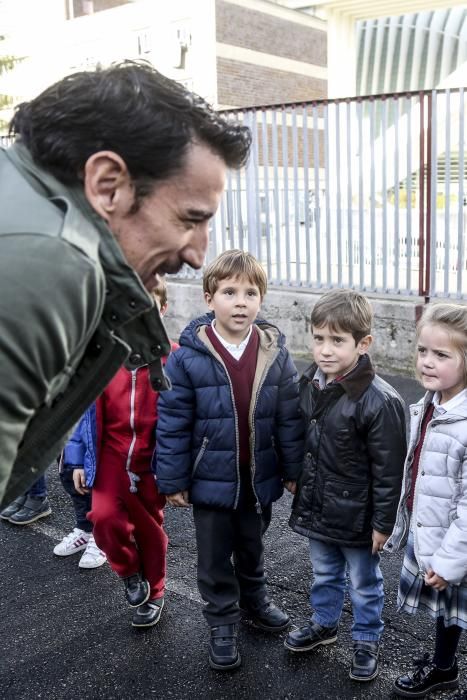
top-left (83, 151), bottom-right (135, 222)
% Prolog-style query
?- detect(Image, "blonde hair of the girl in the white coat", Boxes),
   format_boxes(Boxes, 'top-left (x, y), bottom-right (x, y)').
top-left (415, 304), bottom-right (467, 386)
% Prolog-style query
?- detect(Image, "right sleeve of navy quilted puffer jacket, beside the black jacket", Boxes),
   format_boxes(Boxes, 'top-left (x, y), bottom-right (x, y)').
top-left (276, 350), bottom-right (304, 481)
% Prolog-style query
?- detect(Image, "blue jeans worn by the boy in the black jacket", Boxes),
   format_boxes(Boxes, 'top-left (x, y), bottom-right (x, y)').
top-left (310, 538), bottom-right (384, 642)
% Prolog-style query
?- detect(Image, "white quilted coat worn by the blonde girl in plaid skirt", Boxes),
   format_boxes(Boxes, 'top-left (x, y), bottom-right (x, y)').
top-left (385, 392), bottom-right (467, 585)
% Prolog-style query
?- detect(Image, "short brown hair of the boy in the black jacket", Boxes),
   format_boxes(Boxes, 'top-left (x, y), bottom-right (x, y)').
top-left (311, 289), bottom-right (373, 343)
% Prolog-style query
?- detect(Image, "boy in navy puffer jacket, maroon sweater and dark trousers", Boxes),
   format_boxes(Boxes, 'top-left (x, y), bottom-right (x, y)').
top-left (155, 250), bottom-right (303, 670)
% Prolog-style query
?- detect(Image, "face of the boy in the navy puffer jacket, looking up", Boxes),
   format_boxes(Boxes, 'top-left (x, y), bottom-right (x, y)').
top-left (204, 277), bottom-right (262, 345)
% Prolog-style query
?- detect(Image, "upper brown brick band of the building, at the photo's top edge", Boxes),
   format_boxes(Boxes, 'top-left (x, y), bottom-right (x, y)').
top-left (216, 0), bottom-right (327, 66)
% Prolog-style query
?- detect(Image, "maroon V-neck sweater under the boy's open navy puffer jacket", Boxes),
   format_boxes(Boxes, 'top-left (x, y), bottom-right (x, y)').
top-left (206, 326), bottom-right (259, 466)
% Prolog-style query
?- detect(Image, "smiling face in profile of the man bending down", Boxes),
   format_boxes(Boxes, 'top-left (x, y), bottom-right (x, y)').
top-left (106, 144), bottom-right (226, 291)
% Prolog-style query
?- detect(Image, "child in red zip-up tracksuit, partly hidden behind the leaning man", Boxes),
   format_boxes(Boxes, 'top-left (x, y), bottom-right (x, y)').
top-left (64, 284), bottom-right (178, 627)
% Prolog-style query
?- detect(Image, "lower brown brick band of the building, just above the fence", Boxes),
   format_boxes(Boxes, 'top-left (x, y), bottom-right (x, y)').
top-left (217, 58), bottom-right (327, 107)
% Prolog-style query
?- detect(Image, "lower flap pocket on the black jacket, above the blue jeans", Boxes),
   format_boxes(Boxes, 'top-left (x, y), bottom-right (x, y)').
top-left (322, 480), bottom-right (368, 532)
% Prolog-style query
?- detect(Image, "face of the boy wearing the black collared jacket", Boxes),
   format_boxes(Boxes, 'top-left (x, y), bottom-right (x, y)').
top-left (313, 324), bottom-right (372, 381)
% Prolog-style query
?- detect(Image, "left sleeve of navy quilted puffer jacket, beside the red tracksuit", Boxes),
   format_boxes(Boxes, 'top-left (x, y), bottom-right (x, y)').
top-left (155, 348), bottom-right (195, 494)
